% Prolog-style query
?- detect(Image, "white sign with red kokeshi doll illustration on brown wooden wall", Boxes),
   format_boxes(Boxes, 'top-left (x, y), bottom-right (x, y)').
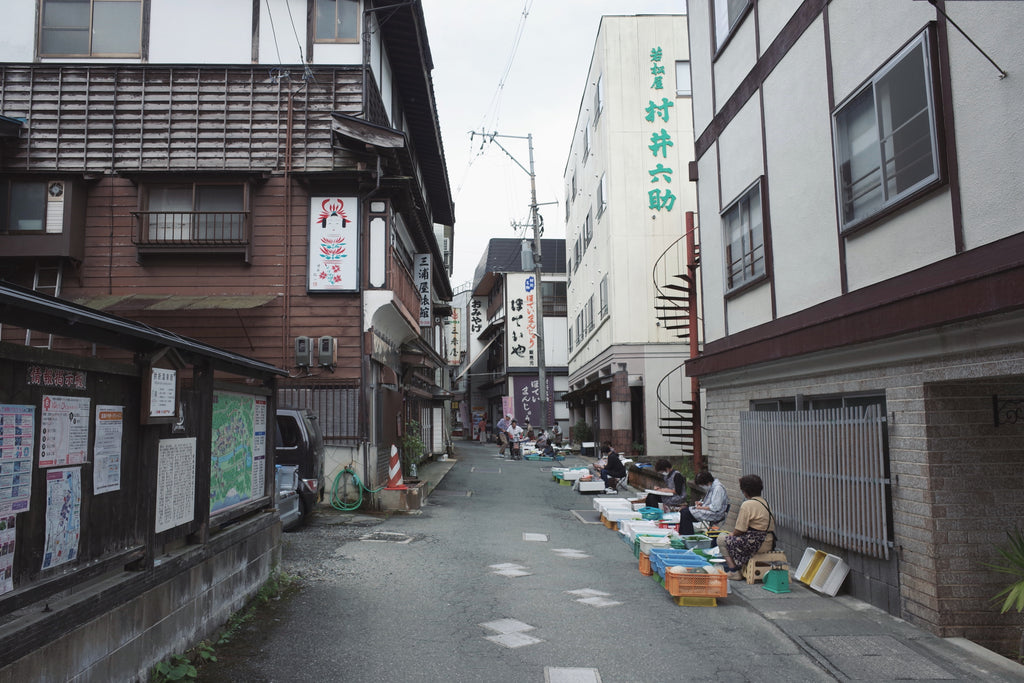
top-left (309, 197), bottom-right (359, 292)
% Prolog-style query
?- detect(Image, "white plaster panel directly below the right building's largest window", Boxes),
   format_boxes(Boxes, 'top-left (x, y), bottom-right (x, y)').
top-left (846, 188), bottom-right (955, 291)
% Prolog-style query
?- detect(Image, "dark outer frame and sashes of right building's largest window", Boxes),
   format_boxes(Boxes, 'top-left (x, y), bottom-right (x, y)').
top-left (831, 29), bottom-right (946, 234)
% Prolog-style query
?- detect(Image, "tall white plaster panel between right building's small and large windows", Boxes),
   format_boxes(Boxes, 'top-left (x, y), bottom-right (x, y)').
top-left (761, 18), bottom-right (842, 316)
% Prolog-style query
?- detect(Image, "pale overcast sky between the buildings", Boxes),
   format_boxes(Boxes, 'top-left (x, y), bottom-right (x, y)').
top-left (423, 0), bottom-right (686, 288)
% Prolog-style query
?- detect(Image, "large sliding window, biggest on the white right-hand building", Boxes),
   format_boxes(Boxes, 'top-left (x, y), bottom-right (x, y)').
top-left (835, 33), bottom-right (939, 228)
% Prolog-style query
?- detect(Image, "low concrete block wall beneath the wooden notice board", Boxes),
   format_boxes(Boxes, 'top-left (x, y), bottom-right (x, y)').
top-left (0, 513), bottom-right (281, 681)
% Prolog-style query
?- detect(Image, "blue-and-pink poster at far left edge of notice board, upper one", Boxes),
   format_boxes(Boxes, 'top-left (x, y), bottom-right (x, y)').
top-left (0, 404), bottom-right (36, 515)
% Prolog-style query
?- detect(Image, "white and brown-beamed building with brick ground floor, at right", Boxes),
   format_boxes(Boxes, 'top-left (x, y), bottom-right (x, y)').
top-left (687, 0), bottom-right (1024, 654)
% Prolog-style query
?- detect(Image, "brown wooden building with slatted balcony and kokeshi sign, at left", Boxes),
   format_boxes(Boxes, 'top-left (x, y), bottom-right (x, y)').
top-left (0, 0), bottom-right (454, 501)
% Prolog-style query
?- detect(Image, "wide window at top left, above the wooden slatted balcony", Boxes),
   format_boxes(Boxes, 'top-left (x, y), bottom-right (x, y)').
top-left (39, 0), bottom-right (142, 57)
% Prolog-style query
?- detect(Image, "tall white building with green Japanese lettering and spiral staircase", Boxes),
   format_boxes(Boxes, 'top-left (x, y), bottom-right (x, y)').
top-left (564, 15), bottom-right (695, 456)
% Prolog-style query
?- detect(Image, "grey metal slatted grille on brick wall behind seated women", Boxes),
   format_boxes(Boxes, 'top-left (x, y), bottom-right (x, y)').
top-left (739, 405), bottom-right (892, 559)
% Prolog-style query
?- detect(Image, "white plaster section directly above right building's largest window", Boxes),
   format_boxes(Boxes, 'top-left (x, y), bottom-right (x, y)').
top-left (828, 0), bottom-right (937, 103)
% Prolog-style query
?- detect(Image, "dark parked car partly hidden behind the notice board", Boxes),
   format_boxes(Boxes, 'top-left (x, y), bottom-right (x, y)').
top-left (274, 407), bottom-right (324, 522)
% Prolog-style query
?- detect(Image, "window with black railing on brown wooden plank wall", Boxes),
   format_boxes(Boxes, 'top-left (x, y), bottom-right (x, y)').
top-left (138, 183), bottom-right (249, 246)
